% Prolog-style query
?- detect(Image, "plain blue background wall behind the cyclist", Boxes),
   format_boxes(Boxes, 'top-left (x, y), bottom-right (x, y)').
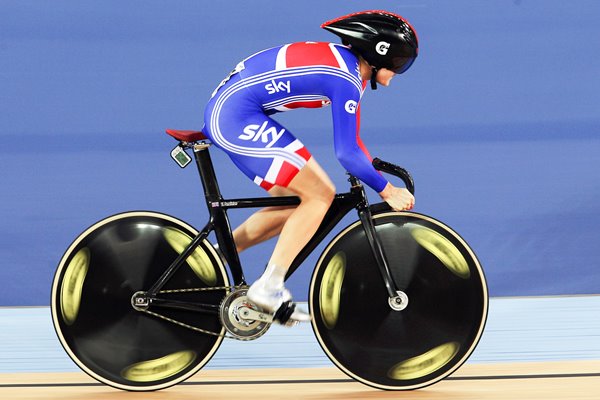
top-left (0, 0), bottom-right (600, 305)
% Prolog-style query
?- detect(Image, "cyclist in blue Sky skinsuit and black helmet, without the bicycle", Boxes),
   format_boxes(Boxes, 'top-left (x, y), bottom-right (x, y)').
top-left (203, 11), bottom-right (418, 323)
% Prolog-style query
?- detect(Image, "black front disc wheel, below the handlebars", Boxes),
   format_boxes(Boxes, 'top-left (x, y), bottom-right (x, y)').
top-left (309, 212), bottom-right (488, 390)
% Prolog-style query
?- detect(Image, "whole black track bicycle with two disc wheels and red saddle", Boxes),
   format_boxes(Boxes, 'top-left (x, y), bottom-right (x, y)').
top-left (51, 130), bottom-right (488, 391)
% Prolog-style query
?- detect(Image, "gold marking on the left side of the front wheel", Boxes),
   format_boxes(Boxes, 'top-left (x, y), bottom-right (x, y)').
top-left (319, 251), bottom-right (346, 329)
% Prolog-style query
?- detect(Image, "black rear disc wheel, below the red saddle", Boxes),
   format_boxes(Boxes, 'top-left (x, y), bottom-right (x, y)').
top-left (51, 212), bottom-right (229, 391)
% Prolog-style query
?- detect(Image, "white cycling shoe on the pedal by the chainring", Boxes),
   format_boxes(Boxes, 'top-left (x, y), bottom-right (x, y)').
top-left (246, 281), bottom-right (311, 326)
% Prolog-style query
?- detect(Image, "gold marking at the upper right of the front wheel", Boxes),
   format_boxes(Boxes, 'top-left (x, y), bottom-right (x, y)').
top-left (406, 223), bottom-right (471, 279)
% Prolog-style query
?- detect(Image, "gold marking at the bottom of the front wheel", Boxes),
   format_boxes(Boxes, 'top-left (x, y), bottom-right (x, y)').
top-left (388, 342), bottom-right (460, 380)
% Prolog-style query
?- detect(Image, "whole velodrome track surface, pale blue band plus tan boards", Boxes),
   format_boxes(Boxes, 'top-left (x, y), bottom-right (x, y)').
top-left (0, 296), bottom-right (600, 399)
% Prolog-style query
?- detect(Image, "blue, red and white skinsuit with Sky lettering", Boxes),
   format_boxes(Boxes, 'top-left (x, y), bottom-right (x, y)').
top-left (204, 42), bottom-right (387, 192)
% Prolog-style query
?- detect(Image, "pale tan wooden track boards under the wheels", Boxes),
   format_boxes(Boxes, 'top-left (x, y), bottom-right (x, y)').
top-left (0, 361), bottom-right (600, 400)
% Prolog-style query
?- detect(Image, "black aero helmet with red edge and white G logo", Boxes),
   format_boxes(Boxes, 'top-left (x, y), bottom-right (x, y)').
top-left (321, 10), bottom-right (419, 74)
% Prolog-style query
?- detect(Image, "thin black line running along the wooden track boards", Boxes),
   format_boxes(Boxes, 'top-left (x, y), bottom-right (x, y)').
top-left (0, 373), bottom-right (600, 389)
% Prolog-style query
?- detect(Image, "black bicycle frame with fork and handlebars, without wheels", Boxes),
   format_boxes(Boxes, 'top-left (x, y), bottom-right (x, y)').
top-left (146, 142), bottom-right (406, 306)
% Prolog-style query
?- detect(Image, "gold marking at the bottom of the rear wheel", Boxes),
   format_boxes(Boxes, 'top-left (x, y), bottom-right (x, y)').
top-left (121, 350), bottom-right (196, 382)
